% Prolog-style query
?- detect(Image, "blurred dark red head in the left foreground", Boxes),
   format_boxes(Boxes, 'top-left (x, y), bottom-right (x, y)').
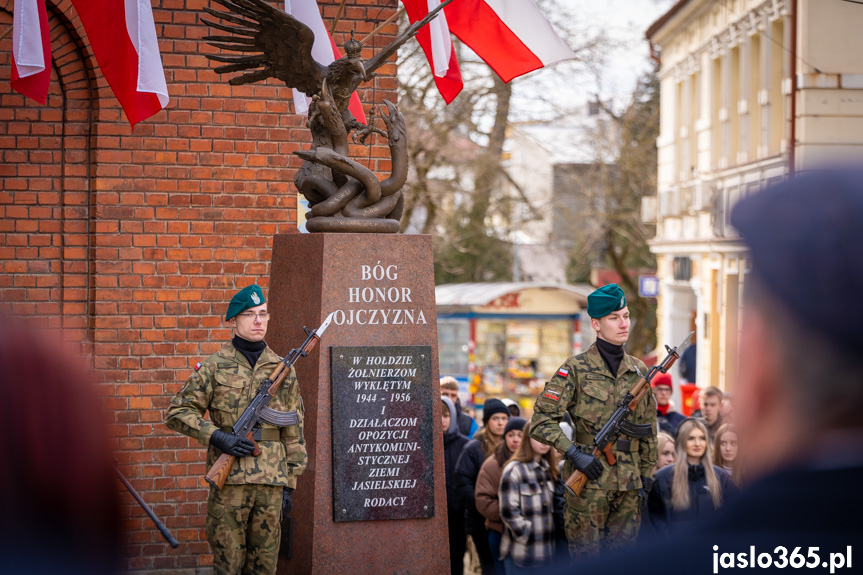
top-left (0, 315), bottom-right (122, 575)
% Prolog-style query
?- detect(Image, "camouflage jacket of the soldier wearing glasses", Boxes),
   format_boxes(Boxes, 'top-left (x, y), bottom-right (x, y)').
top-left (165, 343), bottom-right (307, 487)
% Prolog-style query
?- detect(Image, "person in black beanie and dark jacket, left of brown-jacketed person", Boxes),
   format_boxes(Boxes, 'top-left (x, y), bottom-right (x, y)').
top-left (455, 399), bottom-right (509, 575)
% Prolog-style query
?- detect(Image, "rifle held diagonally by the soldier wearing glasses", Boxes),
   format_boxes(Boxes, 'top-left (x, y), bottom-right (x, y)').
top-left (204, 314), bottom-right (333, 491)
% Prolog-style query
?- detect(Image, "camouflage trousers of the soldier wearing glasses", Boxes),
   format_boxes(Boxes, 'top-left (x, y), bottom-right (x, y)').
top-left (207, 484), bottom-right (285, 575)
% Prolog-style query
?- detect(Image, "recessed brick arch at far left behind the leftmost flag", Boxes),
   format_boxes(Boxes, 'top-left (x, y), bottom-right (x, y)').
top-left (0, 0), bottom-right (93, 342)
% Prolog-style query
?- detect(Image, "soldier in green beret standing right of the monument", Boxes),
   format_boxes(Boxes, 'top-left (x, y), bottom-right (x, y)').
top-left (530, 284), bottom-right (657, 557)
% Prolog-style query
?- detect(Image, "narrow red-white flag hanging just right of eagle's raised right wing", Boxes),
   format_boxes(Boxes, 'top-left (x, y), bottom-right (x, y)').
top-left (402, 0), bottom-right (464, 104)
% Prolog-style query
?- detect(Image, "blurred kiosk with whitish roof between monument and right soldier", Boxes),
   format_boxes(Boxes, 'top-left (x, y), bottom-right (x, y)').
top-left (435, 282), bottom-right (595, 414)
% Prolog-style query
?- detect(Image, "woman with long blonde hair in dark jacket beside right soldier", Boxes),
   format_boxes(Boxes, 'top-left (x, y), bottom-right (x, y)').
top-left (647, 419), bottom-right (738, 534)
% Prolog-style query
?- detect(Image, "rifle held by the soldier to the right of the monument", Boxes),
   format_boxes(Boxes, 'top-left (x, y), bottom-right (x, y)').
top-left (564, 332), bottom-right (695, 497)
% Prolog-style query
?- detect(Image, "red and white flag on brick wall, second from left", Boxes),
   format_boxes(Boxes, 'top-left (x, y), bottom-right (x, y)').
top-left (72, 0), bottom-right (168, 127)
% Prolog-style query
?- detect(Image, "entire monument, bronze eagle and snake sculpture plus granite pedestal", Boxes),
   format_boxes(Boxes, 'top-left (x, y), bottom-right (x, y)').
top-left (204, 0), bottom-right (452, 575)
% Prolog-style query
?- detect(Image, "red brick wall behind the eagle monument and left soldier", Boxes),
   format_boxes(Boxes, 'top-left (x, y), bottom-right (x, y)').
top-left (0, 0), bottom-right (396, 572)
